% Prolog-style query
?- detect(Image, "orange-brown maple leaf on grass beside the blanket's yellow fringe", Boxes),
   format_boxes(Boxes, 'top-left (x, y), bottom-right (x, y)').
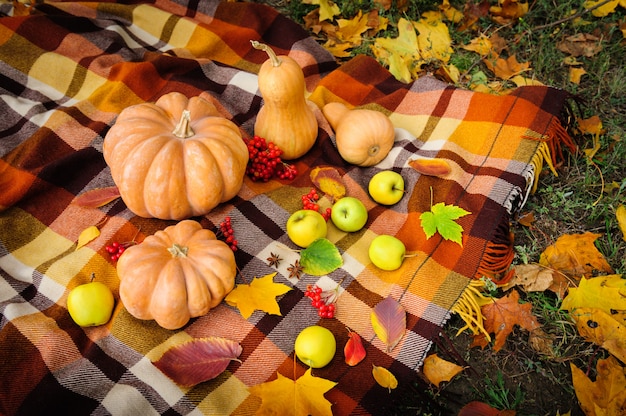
top-left (471, 290), bottom-right (541, 351)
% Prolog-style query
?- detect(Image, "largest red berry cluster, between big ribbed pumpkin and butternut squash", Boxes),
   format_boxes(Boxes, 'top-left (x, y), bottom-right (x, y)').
top-left (244, 135), bottom-right (298, 182)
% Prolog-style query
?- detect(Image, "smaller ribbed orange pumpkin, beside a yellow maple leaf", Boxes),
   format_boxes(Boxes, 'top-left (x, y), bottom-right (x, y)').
top-left (117, 220), bottom-right (237, 329)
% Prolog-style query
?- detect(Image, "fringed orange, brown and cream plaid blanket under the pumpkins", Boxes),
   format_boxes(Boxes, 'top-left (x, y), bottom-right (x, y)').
top-left (0, 0), bottom-right (569, 415)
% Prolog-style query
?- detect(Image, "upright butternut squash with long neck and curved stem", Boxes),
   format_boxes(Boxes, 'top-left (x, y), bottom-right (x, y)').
top-left (252, 41), bottom-right (317, 160)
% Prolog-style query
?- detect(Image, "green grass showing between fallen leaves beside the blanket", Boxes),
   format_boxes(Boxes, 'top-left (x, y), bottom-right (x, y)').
top-left (251, 0), bottom-right (626, 415)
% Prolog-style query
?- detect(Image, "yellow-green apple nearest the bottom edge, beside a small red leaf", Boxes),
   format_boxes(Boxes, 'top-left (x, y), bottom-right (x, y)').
top-left (294, 325), bottom-right (337, 368)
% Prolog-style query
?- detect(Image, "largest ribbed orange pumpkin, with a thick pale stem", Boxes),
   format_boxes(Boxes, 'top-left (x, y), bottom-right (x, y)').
top-left (103, 92), bottom-right (248, 220)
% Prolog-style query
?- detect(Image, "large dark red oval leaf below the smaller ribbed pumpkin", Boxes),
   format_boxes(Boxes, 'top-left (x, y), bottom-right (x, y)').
top-left (153, 337), bottom-right (242, 387)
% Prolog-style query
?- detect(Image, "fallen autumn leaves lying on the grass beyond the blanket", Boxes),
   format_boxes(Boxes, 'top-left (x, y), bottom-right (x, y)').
top-left (286, 0), bottom-right (626, 415)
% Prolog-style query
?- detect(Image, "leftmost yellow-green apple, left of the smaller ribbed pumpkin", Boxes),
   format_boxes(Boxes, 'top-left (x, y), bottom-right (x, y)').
top-left (67, 281), bottom-right (115, 326)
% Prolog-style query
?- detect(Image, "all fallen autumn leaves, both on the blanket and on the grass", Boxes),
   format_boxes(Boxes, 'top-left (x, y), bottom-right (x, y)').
top-left (92, 0), bottom-right (626, 416)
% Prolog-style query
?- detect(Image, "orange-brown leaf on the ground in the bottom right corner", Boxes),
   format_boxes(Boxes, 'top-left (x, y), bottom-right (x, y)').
top-left (570, 356), bottom-right (626, 415)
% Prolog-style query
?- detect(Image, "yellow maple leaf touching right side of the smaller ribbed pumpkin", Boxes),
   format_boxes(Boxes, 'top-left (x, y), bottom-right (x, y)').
top-left (225, 272), bottom-right (291, 319)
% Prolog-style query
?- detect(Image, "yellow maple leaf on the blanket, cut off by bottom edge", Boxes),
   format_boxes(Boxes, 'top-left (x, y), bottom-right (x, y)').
top-left (248, 368), bottom-right (337, 416)
